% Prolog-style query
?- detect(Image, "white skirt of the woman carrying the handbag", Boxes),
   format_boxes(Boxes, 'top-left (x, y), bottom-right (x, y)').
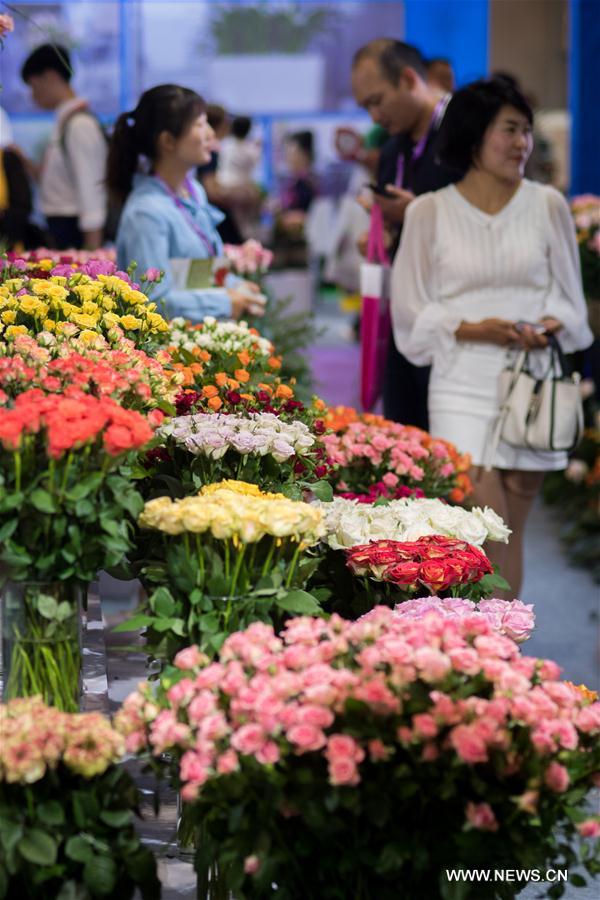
top-left (429, 344), bottom-right (568, 472)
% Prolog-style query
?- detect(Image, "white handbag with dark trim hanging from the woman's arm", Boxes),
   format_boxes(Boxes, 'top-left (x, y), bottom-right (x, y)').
top-left (485, 335), bottom-right (583, 471)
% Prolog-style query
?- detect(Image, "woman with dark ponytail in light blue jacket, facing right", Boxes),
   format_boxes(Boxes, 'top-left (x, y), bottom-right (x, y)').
top-left (107, 84), bottom-right (257, 322)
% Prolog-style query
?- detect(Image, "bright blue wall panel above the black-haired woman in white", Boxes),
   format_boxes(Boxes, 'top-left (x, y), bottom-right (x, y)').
top-left (404, 0), bottom-right (489, 86)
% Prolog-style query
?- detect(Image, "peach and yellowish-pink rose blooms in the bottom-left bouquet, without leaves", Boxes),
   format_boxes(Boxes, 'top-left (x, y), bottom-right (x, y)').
top-left (0, 697), bottom-right (125, 784)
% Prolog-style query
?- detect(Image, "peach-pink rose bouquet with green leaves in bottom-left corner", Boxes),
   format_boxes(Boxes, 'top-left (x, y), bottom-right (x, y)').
top-left (0, 697), bottom-right (160, 900)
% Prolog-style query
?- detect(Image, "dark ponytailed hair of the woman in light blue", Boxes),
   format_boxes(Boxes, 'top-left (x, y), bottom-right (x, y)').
top-left (106, 84), bottom-right (206, 202)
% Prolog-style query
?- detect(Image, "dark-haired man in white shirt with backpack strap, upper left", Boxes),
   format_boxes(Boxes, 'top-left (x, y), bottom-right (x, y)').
top-left (21, 44), bottom-right (107, 250)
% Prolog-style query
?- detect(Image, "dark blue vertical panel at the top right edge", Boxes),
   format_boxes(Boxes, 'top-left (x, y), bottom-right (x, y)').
top-left (569, 0), bottom-right (600, 194)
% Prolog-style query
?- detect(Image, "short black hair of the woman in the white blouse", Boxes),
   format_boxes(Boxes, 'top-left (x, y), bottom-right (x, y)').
top-left (439, 78), bottom-right (533, 174)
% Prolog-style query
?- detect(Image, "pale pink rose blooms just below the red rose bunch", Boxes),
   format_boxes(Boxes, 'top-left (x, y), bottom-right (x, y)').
top-left (386, 597), bottom-right (535, 644)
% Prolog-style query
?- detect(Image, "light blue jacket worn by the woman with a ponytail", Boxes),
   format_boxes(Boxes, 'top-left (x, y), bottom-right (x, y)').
top-left (117, 175), bottom-right (237, 322)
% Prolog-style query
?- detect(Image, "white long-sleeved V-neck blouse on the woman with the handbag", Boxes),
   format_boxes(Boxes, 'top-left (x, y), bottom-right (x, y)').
top-left (391, 180), bottom-right (593, 375)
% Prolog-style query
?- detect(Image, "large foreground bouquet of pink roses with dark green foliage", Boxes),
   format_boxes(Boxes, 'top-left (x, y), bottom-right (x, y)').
top-left (116, 608), bottom-right (600, 900)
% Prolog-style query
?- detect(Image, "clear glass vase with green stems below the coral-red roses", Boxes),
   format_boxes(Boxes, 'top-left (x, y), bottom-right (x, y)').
top-left (0, 581), bottom-right (85, 712)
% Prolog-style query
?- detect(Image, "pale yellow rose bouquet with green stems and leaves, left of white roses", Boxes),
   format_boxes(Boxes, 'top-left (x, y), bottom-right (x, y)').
top-left (118, 481), bottom-right (324, 660)
